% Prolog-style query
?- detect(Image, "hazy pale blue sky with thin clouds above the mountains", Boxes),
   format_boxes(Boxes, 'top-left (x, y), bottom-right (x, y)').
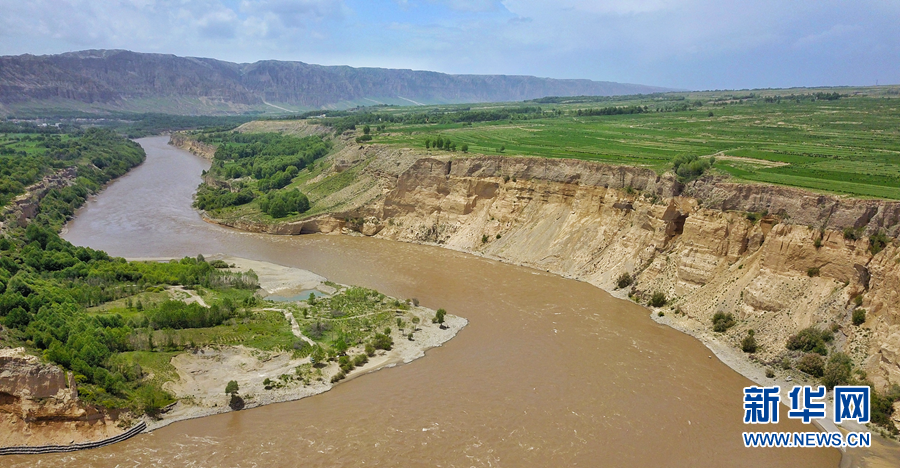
top-left (0, 0), bottom-right (900, 89)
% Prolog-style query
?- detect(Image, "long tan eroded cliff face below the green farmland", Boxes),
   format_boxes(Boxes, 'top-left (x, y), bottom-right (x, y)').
top-left (274, 147), bottom-right (900, 388)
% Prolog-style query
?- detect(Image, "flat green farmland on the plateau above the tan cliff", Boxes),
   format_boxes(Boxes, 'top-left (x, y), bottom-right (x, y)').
top-left (346, 87), bottom-right (900, 199)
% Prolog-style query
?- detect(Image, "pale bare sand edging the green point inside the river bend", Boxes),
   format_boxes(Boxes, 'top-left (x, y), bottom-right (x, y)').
top-left (124, 255), bottom-right (468, 431)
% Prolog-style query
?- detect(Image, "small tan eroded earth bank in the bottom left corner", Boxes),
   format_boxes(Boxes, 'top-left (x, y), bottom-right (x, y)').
top-left (0, 348), bottom-right (123, 446)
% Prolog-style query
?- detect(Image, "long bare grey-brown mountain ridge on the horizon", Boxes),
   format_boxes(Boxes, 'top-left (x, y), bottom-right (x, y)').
top-left (0, 50), bottom-right (667, 113)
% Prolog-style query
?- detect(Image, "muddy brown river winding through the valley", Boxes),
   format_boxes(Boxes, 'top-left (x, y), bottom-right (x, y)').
top-left (21, 137), bottom-right (840, 468)
